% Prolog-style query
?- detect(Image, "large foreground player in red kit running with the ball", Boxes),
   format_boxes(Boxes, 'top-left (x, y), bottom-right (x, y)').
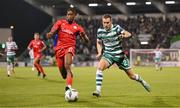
top-left (47, 8), bottom-right (89, 90)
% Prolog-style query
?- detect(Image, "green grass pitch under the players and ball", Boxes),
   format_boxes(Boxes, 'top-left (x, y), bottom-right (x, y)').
top-left (0, 67), bottom-right (180, 108)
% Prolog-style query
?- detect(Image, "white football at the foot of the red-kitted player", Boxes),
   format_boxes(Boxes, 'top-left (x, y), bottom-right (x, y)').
top-left (65, 89), bottom-right (78, 102)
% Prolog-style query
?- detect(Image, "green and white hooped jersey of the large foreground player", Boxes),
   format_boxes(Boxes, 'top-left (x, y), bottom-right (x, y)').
top-left (97, 25), bottom-right (124, 58)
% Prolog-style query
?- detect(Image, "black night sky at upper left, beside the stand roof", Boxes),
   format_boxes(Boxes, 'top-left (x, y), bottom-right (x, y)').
top-left (0, 0), bottom-right (52, 55)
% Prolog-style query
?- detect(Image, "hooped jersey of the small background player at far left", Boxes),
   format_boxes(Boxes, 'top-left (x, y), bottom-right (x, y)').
top-left (6, 41), bottom-right (18, 56)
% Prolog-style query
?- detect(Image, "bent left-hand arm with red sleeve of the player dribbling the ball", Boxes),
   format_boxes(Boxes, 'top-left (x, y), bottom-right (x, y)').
top-left (46, 20), bottom-right (62, 39)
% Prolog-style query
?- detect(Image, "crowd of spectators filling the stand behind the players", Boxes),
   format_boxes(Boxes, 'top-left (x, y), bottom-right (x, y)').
top-left (39, 16), bottom-right (180, 61)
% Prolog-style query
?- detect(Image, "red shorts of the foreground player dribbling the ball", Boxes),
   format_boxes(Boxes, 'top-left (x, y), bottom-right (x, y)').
top-left (56, 47), bottom-right (75, 68)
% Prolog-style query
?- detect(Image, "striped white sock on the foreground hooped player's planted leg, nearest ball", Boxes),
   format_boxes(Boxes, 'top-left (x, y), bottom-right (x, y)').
top-left (96, 69), bottom-right (103, 92)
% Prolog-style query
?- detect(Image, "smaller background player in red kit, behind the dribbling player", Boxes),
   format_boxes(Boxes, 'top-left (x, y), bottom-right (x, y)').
top-left (28, 33), bottom-right (46, 78)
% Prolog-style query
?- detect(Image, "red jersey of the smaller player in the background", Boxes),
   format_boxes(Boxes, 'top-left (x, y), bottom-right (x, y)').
top-left (29, 39), bottom-right (45, 57)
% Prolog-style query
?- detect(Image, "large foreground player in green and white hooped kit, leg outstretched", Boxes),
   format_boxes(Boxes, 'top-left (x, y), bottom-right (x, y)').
top-left (93, 14), bottom-right (151, 97)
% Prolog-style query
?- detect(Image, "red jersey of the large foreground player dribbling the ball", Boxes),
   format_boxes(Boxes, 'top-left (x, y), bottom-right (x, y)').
top-left (51, 20), bottom-right (84, 51)
